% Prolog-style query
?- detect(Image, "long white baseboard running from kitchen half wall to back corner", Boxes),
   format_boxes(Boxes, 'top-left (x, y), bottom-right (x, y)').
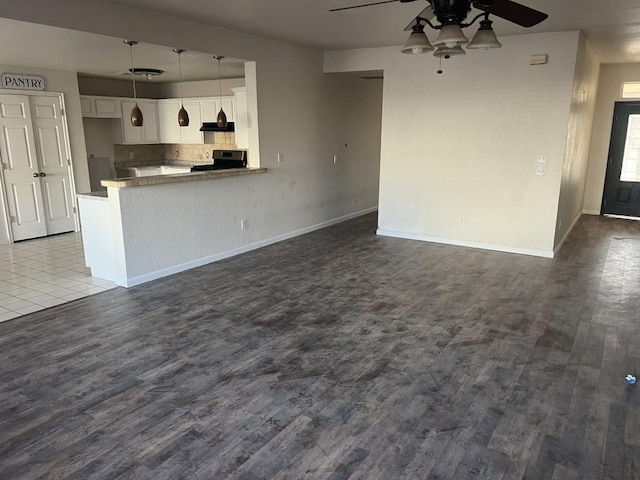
top-left (115, 206), bottom-right (378, 287)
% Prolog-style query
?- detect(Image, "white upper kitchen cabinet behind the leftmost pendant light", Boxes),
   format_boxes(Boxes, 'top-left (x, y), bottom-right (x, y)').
top-left (113, 98), bottom-right (160, 145)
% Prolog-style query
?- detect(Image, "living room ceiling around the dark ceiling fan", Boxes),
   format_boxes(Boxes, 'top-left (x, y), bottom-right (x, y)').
top-left (108, 0), bottom-right (640, 63)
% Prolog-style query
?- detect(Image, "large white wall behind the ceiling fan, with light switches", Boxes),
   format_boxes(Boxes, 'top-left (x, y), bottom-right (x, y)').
top-left (325, 32), bottom-right (579, 256)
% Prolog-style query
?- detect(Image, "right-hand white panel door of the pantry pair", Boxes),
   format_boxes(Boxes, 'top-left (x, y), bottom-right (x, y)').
top-left (29, 95), bottom-right (76, 235)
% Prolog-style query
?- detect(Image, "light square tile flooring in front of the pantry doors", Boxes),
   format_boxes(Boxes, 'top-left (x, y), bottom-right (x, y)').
top-left (0, 233), bottom-right (115, 322)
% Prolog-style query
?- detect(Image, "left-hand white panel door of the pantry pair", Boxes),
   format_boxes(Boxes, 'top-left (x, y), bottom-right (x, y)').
top-left (0, 95), bottom-right (47, 241)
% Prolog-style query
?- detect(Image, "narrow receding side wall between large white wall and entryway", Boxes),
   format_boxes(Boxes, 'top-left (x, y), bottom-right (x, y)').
top-left (554, 35), bottom-right (600, 250)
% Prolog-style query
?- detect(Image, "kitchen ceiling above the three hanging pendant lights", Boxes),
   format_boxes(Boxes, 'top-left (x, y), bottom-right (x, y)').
top-left (0, 18), bottom-right (244, 83)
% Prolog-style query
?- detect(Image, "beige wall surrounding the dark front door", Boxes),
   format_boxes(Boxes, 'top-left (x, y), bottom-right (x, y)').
top-left (584, 63), bottom-right (640, 215)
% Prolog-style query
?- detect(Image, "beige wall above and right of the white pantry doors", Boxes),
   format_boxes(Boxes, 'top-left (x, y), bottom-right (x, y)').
top-left (0, 64), bottom-right (90, 243)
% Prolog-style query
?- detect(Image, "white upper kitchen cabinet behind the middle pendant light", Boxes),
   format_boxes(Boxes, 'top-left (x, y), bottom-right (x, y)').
top-left (158, 99), bottom-right (204, 144)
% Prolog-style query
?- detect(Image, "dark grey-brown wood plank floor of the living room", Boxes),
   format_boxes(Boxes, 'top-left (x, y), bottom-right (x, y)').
top-left (0, 215), bottom-right (640, 480)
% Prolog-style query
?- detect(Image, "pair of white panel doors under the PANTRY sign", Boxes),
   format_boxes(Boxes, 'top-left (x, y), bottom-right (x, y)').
top-left (0, 95), bottom-right (75, 241)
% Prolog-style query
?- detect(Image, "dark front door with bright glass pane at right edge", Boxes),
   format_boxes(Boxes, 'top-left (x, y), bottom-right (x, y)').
top-left (600, 102), bottom-right (640, 217)
